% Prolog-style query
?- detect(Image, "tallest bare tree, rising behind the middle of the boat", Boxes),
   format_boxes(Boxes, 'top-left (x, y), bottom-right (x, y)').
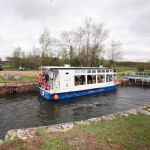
top-left (82, 18), bottom-right (108, 66)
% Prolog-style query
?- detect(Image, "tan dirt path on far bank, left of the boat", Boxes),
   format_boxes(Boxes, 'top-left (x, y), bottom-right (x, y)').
top-left (0, 70), bottom-right (39, 76)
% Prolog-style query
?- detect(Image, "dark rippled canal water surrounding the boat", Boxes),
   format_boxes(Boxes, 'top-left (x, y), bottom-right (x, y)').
top-left (0, 87), bottom-right (150, 138)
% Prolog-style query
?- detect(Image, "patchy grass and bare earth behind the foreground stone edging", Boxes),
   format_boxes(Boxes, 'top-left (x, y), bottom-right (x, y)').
top-left (0, 114), bottom-right (150, 150)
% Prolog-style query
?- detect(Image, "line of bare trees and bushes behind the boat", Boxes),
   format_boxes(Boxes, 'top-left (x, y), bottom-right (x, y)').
top-left (5, 18), bottom-right (123, 69)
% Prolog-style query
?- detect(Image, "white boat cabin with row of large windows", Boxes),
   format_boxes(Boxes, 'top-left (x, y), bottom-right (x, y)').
top-left (42, 65), bottom-right (116, 93)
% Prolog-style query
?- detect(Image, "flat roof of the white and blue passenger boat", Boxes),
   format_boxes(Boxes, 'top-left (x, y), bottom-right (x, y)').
top-left (42, 66), bottom-right (114, 70)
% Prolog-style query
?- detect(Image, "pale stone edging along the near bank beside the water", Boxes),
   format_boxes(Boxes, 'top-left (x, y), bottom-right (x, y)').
top-left (5, 105), bottom-right (150, 140)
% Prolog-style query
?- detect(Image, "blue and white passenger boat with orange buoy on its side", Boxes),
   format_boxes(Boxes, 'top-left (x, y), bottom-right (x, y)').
top-left (38, 65), bottom-right (118, 101)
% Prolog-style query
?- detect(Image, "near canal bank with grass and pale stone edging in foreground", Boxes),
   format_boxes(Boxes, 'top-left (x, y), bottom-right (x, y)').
top-left (0, 105), bottom-right (150, 150)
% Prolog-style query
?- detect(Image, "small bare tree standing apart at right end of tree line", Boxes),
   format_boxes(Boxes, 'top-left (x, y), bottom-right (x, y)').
top-left (108, 40), bottom-right (123, 63)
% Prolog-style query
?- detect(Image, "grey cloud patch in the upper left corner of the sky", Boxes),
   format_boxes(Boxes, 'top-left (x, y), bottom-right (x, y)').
top-left (0, 0), bottom-right (64, 20)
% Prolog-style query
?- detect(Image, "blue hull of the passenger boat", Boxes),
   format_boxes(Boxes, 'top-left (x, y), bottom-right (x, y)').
top-left (39, 86), bottom-right (116, 101)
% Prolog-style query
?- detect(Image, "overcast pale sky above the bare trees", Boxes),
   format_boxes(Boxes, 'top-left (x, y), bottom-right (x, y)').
top-left (0, 0), bottom-right (150, 61)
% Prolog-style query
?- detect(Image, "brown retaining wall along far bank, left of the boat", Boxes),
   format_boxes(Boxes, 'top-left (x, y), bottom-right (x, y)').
top-left (0, 83), bottom-right (37, 95)
